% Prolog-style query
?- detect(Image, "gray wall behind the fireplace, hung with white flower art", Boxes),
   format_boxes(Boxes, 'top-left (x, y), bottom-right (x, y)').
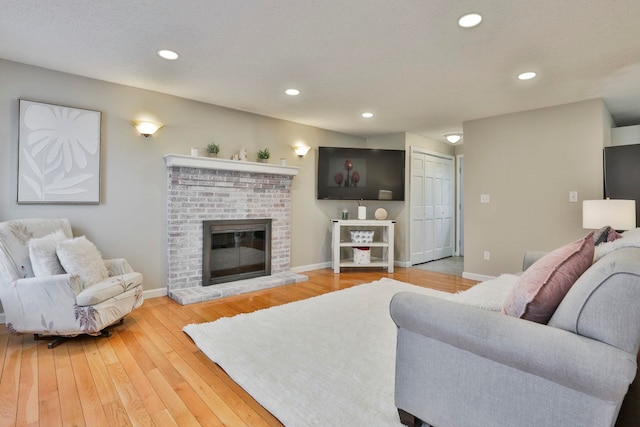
top-left (0, 60), bottom-right (365, 308)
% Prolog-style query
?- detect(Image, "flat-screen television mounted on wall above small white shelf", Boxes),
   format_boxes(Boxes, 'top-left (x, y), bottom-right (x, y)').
top-left (317, 147), bottom-right (405, 200)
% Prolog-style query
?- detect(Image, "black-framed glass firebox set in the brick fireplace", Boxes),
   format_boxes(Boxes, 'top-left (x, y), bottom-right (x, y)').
top-left (202, 218), bottom-right (271, 286)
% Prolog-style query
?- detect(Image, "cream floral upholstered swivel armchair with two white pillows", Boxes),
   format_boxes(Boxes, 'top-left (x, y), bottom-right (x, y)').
top-left (0, 219), bottom-right (143, 348)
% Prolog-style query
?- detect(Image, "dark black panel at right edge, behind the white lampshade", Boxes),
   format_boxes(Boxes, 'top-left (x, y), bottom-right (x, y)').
top-left (604, 144), bottom-right (640, 225)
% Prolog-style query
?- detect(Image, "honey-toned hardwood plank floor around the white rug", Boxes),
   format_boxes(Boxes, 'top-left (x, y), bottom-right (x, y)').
top-left (0, 268), bottom-right (475, 427)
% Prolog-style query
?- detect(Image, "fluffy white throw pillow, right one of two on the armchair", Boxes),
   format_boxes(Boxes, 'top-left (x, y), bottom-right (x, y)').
top-left (56, 236), bottom-right (109, 289)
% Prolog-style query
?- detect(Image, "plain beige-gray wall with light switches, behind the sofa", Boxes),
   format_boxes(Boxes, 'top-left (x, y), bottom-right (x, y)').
top-left (464, 99), bottom-right (613, 276)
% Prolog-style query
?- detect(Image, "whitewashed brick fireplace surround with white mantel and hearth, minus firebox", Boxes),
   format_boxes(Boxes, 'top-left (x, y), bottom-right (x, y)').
top-left (165, 154), bottom-right (307, 304)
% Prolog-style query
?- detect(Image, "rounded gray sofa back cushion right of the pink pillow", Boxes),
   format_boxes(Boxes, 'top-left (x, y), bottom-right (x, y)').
top-left (549, 247), bottom-right (640, 354)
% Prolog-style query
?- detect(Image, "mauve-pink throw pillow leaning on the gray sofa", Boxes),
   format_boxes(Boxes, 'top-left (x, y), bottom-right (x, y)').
top-left (502, 232), bottom-right (594, 324)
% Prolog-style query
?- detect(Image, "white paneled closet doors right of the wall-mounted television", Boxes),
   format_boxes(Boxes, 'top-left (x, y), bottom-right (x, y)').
top-left (410, 149), bottom-right (455, 264)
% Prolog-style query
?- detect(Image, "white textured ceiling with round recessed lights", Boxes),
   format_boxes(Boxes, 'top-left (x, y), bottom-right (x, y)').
top-left (0, 0), bottom-right (640, 141)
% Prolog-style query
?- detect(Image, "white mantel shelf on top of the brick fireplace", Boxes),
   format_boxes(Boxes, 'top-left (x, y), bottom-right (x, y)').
top-left (164, 154), bottom-right (298, 176)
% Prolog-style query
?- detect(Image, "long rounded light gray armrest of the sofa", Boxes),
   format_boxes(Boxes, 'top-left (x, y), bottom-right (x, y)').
top-left (390, 292), bottom-right (636, 401)
